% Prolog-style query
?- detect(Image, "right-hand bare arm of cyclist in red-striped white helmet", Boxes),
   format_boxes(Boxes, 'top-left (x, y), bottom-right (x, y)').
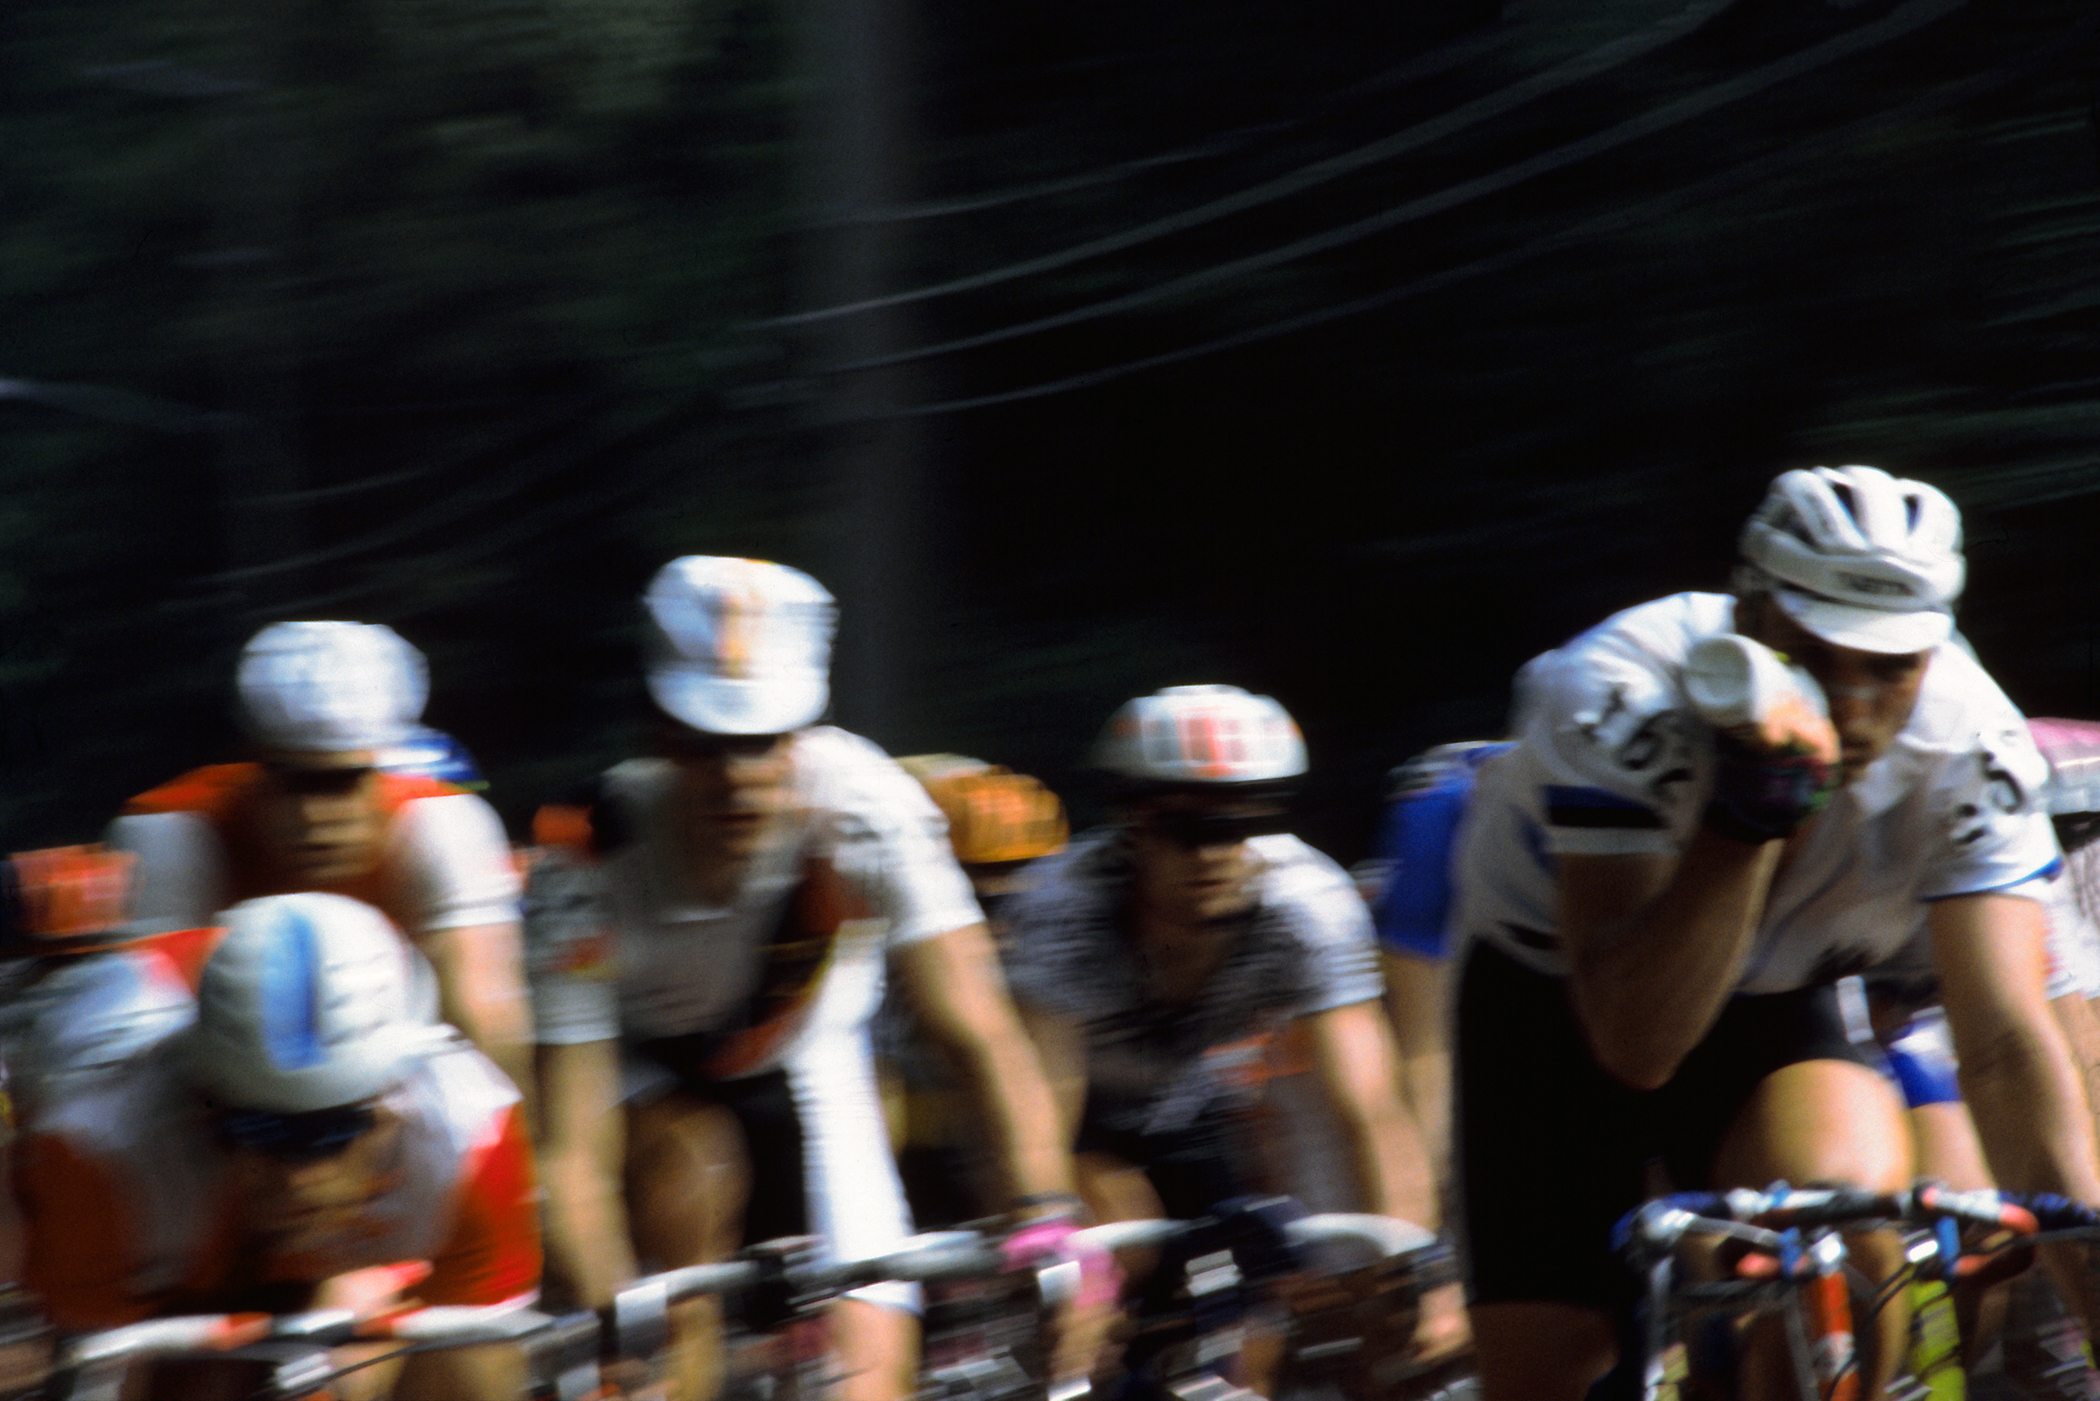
top-left (1304, 1002), bottom-right (1436, 1231)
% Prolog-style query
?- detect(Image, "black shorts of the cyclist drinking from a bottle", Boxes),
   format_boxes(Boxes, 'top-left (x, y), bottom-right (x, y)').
top-left (1457, 941), bottom-right (1869, 1313)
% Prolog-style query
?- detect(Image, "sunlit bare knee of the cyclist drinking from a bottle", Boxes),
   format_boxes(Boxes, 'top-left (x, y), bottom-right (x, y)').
top-left (1714, 1061), bottom-right (1913, 1191)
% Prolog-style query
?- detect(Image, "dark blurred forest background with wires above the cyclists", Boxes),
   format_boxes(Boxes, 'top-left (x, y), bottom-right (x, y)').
top-left (0, 0), bottom-right (2100, 859)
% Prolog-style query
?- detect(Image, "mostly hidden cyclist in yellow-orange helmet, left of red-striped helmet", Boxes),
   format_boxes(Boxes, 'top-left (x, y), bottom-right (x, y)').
top-left (874, 754), bottom-right (1071, 1229)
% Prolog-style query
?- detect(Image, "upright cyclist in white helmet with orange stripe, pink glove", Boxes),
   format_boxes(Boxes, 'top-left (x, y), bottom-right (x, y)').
top-left (527, 555), bottom-right (1071, 1399)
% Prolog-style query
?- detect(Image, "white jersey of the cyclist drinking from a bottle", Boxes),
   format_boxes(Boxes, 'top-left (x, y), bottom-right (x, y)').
top-left (1453, 594), bottom-right (2058, 994)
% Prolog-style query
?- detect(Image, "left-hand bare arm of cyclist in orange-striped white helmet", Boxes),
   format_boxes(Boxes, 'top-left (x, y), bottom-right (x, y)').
top-left (540, 1042), bottom-right (634, 1309)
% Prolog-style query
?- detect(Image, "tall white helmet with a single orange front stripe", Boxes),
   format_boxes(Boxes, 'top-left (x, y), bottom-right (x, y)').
top-left (643, 555), bottom-right (838, 735)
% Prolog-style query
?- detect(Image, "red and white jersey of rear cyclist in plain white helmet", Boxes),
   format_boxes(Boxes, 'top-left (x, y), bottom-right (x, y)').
top-left (107, 765), bottom-right (521, 937)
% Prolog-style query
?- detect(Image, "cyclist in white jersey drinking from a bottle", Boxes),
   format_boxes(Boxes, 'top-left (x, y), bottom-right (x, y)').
top-left (1453, 466), bottom-right (2100, 1401)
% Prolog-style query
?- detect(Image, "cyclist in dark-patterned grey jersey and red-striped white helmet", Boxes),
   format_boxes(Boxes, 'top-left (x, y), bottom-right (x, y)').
top-left (986, 685), bottom-right (1457, 1346)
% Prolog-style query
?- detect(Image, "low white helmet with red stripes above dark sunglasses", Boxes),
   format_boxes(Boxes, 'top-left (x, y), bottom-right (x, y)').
top-left (1094, 687), bottom-right (1306, 786)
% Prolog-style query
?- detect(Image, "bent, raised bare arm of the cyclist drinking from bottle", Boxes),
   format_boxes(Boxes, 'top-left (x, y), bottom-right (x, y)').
top-left (1556, 828), bottom-right (1783, 1090)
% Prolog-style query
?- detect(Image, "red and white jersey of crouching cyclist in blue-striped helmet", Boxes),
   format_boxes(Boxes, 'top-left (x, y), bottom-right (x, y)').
top-left (13, 1027), bottom-right (540, 1330)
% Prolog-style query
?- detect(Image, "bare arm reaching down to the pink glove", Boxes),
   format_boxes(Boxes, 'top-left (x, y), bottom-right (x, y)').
top-left (893, 924), bottom-right (1073, 1197)
